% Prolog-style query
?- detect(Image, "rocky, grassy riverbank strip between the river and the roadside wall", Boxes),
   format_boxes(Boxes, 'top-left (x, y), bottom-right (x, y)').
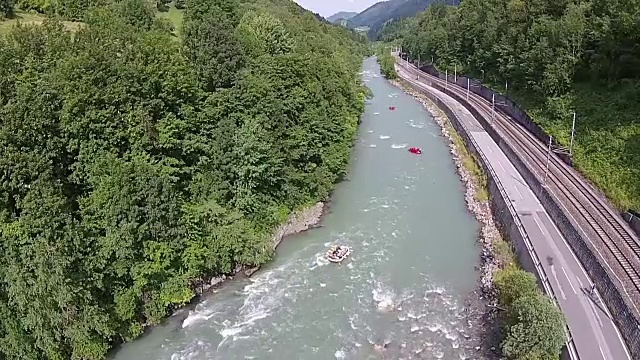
top-left (389, 80), bottom-right (515, 358)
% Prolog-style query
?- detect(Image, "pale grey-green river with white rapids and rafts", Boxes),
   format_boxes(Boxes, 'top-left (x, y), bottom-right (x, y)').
top-left (112, 58), bottom-right (479, 360)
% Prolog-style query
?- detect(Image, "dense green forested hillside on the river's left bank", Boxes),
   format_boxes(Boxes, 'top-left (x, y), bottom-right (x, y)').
top-left (0, 0), bottom-right (366, 360)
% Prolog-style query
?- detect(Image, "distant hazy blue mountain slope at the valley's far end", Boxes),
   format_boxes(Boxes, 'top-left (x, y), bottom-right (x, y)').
top-left (348, 0), bottom-right (460, 39)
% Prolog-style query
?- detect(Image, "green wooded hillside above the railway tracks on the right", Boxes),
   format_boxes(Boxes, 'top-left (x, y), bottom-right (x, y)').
top-left (383, 0), bottom-right (640, 211)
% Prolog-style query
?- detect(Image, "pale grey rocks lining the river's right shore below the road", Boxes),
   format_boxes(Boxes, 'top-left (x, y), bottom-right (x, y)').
top-left (390, 80), bottom-right (503, 358)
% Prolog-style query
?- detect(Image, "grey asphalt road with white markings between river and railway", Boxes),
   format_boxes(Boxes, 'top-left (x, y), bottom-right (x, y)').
top-left (397, 64), bottom-right (631, 360)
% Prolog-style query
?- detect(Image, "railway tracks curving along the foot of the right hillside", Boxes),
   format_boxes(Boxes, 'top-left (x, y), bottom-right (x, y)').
top-left (400, 61), bottom-right (640, 313)
